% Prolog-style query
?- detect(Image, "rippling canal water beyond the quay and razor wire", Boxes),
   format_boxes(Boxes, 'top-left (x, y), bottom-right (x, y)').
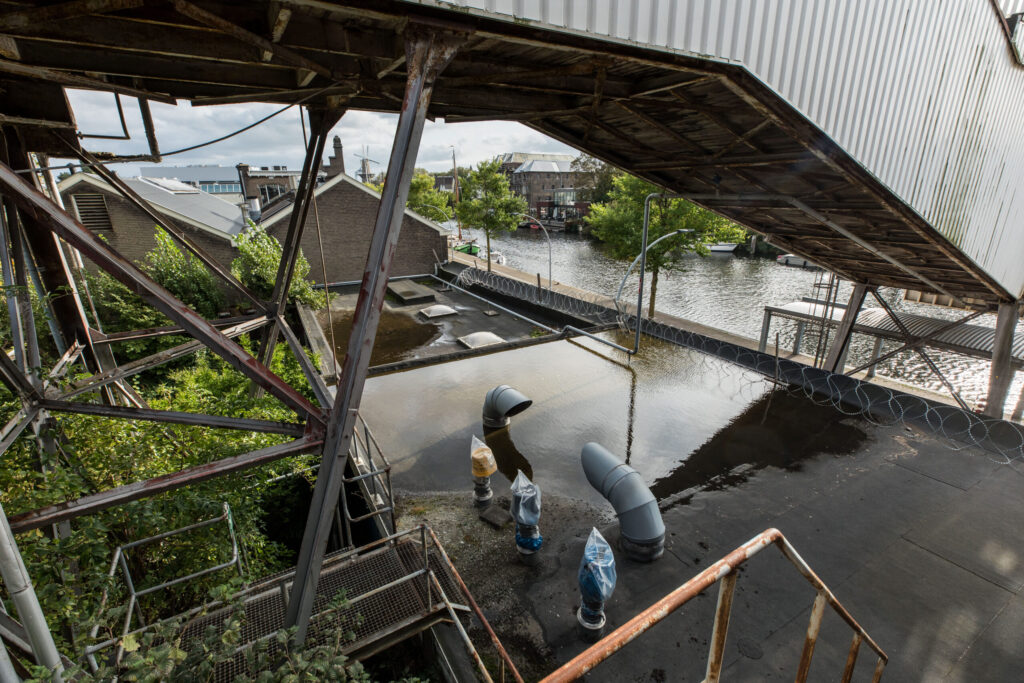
top-left (463, 224), bottom-right (1024, 405)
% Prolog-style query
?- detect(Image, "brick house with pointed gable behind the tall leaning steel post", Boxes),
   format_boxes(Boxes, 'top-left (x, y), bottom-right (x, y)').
top-left (261, 173), bottom-right (449, 283)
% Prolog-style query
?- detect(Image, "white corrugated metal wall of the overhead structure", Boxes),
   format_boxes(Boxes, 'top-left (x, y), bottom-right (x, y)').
top-left (409, 0), bottom-right (1024, 294)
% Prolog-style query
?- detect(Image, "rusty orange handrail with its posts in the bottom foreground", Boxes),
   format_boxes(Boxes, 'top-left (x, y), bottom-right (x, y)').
top-left (542, 528), bottom-right (889, 683)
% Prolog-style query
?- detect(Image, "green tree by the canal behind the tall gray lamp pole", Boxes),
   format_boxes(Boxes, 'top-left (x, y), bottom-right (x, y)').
top-left (587, 173), bottom-right (732, 315)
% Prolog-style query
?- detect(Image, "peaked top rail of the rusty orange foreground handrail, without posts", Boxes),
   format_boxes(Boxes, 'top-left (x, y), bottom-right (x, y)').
top-left (542, 528), bottom-right (889, 683)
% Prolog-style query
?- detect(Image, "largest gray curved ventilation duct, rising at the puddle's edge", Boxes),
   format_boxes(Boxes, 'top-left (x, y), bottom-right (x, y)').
top-left (580, 442), bottom-right (665, 562)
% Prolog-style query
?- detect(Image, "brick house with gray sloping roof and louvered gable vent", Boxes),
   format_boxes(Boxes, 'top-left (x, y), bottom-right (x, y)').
top-left (57, 173), bottom-right (245, 267)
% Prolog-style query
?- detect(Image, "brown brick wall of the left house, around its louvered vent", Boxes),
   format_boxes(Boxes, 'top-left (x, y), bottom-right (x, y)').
top-left (60, 187), bottom-right (234, 270)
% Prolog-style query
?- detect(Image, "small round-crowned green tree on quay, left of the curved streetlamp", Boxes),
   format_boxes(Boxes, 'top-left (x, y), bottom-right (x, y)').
top-left (455, 159), bottom-right (526, 271)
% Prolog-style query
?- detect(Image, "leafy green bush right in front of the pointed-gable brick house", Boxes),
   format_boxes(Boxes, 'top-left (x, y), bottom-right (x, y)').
top-left (231, 223), bottom-right (324, 306)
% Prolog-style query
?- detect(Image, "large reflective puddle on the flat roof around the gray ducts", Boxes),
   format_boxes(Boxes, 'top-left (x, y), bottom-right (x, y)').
top-left (360, 331), bottom-right (865, 502)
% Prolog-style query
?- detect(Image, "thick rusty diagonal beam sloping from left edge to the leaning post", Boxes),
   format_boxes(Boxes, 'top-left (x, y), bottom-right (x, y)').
top-left (0, 164), bottom-right (323, 422)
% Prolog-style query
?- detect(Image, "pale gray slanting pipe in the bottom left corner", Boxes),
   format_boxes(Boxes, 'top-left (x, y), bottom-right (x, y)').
top-left (0, 506), bottom-right (63, 683)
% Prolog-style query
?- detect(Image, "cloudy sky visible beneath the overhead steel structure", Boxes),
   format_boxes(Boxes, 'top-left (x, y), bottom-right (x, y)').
top-left (59, 90), bottom-right (575, 176)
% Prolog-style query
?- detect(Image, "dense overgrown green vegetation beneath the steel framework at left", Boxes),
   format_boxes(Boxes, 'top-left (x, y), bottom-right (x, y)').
top-left (0, 228), bottom-right (366, 681)
